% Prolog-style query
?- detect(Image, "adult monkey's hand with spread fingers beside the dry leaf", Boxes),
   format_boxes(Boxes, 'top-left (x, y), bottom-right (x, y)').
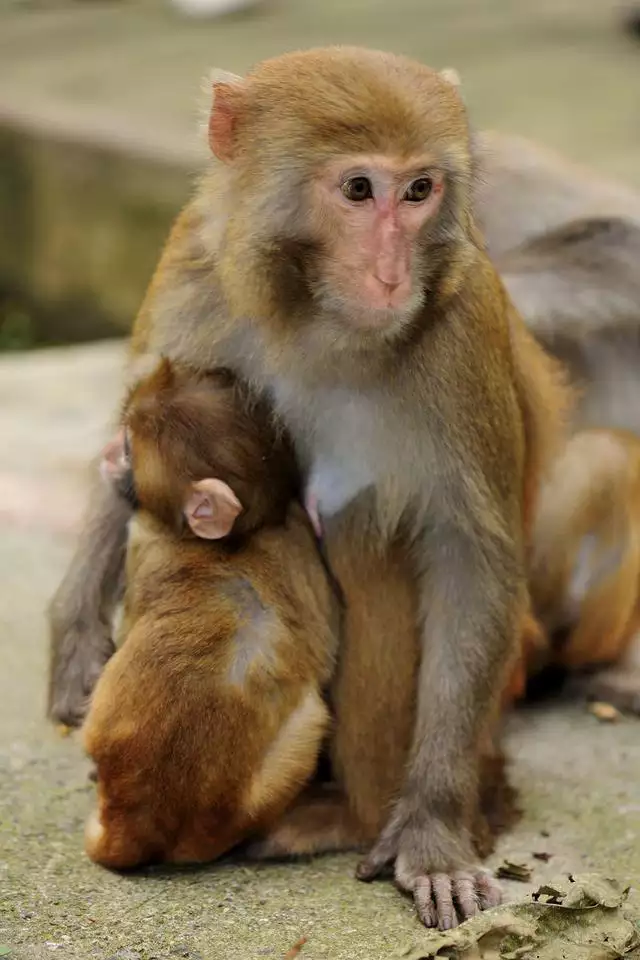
top-left (356, 801), bottom-right (502, 930)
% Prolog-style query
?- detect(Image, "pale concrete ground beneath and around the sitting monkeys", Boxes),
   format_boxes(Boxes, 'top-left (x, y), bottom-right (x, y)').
top-left (0, 343), bottom-right (640, 960)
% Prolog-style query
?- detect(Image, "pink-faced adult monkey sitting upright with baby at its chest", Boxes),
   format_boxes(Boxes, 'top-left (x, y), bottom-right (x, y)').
top-left (54, 48), bottom-right (564, 927)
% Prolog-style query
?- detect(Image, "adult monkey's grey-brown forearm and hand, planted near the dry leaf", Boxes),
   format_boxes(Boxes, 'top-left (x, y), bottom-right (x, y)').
top-left (358, 518), bottom-right (525, 930)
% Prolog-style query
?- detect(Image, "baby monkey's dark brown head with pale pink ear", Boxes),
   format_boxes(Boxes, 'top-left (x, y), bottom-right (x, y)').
top-left (102, 360), bottom-right (299, 540)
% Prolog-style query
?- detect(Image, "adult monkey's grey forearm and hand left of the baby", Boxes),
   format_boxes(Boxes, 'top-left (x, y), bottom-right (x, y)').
top-left (48, 470), bottom-right (131, 726)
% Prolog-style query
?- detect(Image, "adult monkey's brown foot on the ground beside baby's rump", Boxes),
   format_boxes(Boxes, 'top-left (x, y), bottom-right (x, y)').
top-left (246, 787), bottom-right (373, 860)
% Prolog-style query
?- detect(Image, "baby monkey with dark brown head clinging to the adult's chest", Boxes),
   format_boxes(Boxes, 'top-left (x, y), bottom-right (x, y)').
top-left (83, 360), bottom-right (339, 868)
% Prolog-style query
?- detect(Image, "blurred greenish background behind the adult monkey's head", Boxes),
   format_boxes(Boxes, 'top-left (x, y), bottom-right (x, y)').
top-left (0, 0), bottom-right (640, 349)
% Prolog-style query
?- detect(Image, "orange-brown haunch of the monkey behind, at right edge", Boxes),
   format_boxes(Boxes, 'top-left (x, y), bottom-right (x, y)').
top-left (528, 430), bottom-right (640, 713)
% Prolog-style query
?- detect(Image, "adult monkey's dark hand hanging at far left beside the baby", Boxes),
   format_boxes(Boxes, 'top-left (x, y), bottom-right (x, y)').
top-left (48, 613), bottom-right (115, 727)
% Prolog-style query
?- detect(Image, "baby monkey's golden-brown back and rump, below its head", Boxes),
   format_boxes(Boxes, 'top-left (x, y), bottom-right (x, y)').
top-left (84, 505), bottom-right (337, 867)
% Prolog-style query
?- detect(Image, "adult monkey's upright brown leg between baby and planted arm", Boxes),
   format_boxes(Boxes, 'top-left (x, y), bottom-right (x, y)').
top-left (328, 540), bottom-right (420, 837)
